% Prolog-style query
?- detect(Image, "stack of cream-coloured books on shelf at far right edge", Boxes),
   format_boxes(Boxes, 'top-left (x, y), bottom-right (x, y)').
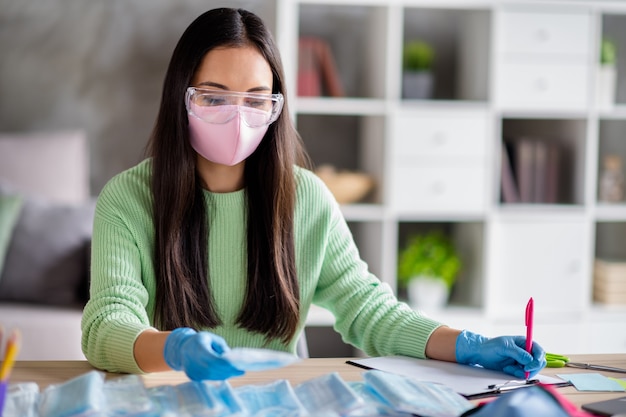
top-left (593, 259), bottom-right (626, 305)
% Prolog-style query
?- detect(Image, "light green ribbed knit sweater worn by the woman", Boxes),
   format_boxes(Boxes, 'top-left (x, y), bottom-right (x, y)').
top-left (82, 159), bottom-right (441, 373)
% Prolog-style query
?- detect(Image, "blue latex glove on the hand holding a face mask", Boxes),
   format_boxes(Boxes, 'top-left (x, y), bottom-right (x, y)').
top-left (163, 327), bottom-right (244, 381)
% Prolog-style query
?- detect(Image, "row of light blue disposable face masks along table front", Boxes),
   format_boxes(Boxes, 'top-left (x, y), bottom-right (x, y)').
top-left (3, 370), bottom-right (473, 417)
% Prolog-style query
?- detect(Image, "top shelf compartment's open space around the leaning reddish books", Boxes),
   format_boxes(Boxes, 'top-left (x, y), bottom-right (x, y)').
top-left (298, 4), bottom-right (388, 98)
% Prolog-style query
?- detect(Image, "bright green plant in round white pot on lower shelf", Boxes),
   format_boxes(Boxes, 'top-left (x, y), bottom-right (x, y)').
top-left (398, 230), bottom-right (461, 310)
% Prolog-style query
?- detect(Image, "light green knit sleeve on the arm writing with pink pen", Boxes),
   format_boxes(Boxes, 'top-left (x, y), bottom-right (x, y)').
top-left (313, 177), bottom-right (442, 358)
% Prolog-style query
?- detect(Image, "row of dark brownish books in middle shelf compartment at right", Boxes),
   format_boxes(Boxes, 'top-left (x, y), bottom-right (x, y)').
top-left (501, 137), bottom-right (561, 204)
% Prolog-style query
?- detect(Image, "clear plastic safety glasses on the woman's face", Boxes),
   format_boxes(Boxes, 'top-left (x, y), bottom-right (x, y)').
top-left (185, 87), bottom-right (284, 127)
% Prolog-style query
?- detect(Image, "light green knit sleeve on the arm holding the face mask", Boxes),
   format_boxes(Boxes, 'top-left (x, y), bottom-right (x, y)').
top-left (81, 164), bottom-right (152, 373)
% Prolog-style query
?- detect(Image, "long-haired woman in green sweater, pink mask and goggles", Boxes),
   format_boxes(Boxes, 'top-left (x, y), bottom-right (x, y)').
top-left (82, 9), bottom-right (545, 379)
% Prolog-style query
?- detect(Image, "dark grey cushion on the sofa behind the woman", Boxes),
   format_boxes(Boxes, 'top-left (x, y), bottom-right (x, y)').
top-left (0, 189), bottom-right (95, 305)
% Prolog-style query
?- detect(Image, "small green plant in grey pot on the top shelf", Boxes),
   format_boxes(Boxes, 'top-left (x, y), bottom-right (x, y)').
top-left (402, 40), bottom-right (435, 99)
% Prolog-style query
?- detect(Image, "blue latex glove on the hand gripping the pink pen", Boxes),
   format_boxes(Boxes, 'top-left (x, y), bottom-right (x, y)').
top-left (456, 330), bottom-right (546, 379)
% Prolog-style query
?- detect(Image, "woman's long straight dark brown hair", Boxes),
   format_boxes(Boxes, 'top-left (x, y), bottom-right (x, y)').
top-left (148, 8), bottom-right (308, 343)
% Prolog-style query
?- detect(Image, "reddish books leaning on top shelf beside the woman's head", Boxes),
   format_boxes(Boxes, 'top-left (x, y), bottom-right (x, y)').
top-left (297, 36), bottom-right (344, 97)
